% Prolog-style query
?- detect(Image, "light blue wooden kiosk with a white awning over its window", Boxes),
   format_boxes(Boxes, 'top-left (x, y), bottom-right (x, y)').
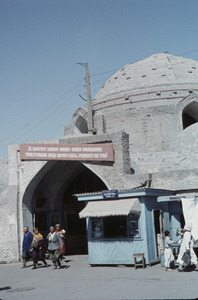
top-left (75, 188), bottom-right (182, 265)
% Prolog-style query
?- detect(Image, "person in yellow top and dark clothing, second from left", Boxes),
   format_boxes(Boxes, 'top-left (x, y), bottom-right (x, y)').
top-left (31, 228), bottom-right (47, 269)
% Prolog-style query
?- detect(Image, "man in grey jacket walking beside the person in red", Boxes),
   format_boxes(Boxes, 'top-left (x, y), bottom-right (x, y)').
top-left (47, 226), bottom-right (63, 270)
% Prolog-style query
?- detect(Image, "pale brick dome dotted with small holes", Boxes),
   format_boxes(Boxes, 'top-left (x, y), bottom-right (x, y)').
top-left (93, 53), bottom-right (198, 111)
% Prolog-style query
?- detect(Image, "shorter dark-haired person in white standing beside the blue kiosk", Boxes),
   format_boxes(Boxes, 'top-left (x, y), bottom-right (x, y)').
top-left (164, 230), bottom-right (176, 271)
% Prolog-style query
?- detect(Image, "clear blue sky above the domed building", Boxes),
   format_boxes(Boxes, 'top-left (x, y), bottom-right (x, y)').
top-left (0, 0), bottom-right (198, 158)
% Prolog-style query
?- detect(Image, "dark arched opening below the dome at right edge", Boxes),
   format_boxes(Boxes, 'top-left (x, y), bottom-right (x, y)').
top-left (182, 102), bottom-right (198, 129)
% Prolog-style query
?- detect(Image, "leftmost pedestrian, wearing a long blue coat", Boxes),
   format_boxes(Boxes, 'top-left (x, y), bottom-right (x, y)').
top-left (22, 226), bottom-right (33, 268)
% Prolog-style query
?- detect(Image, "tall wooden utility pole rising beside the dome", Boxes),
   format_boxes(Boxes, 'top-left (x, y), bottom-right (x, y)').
top-left (78, 63), bottom-right (93, 134)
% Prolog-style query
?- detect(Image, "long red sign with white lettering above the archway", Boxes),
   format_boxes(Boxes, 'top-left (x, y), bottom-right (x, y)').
top-left (20, 144), bottom-right (114, 161)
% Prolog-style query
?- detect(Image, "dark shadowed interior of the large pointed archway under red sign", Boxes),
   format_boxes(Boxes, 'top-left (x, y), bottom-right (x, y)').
top-left (23, 161), bottom-right (107, 254)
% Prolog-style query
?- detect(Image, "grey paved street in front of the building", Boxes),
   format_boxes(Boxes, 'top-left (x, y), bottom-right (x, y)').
top-left (0, 255), bottom-right (198, 300)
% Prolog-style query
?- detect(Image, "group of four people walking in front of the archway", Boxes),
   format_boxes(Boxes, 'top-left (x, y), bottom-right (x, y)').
top-left (22, 224), bottom-right (65, 270)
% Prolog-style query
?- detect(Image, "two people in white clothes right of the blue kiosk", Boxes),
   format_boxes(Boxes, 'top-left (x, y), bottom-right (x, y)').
top-left (164, 225), bottom-right (198, 272)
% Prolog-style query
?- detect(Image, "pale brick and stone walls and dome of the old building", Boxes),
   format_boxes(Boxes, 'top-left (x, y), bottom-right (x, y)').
top-left (0, 54), bottom-right (198, 261)
